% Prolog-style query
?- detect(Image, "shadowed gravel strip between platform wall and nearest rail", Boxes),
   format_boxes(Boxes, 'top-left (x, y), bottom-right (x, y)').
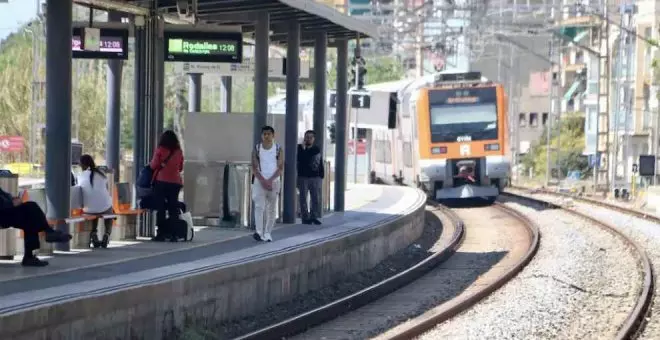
top-left (180, 212), bottom-right (442, 339)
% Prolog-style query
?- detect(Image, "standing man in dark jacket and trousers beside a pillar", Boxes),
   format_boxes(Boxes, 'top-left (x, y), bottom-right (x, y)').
top-left (298, 130), bottom-right (325, 225)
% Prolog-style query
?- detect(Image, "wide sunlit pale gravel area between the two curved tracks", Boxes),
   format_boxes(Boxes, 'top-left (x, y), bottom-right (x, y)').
top-left (419, 202), bottom-right (643, 340)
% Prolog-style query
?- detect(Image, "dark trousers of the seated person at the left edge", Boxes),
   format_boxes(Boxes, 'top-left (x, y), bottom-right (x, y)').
top-left (0, 202), bottom-right (52, 254)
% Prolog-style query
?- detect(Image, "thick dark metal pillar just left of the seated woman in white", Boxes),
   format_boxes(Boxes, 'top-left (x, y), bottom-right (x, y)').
top-left (46, 0), bottom-right (73, 251)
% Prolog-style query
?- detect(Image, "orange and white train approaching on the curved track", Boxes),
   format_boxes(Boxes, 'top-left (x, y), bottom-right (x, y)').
top-left (367, 72), bottom-right (511, 203)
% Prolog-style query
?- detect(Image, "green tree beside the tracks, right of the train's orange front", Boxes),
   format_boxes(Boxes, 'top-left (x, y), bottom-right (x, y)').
top-left (521, 113), bottom-right (590, 176)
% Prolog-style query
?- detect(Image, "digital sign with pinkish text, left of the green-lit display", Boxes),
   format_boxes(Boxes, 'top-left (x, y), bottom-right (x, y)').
top-left (71, 27), bottom-right (128, 59)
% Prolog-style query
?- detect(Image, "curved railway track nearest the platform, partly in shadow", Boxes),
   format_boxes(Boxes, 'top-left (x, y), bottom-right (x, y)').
top-left (237, 202), bottom-right (540, 339)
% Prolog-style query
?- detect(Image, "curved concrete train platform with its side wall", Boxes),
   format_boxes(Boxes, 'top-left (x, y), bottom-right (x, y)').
top-left (0, 184), bottom-right (425, 339)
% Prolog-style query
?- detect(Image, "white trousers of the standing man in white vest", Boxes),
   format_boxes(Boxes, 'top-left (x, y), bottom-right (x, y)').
top-left (252, 178), bottom-right (280, 238)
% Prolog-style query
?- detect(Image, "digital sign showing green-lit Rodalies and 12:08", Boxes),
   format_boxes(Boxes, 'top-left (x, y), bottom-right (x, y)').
top-left (165, 31), bottom-right (243, 63)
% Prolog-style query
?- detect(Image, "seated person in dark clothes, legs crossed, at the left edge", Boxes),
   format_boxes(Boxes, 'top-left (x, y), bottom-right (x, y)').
top-left (0, 188), bottom-right (71, 267)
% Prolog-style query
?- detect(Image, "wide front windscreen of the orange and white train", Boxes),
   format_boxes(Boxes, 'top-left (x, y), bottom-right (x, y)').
top-left (431, 103), bottom-right (497, 143)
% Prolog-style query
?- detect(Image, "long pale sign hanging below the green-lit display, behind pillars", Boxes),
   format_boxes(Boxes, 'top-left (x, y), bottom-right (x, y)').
top-left (174, 58), bottom-right (310, 79)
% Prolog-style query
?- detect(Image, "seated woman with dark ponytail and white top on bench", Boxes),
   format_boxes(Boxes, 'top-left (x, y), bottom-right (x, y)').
top-left (78, 155), bottom-right (114, 248)
